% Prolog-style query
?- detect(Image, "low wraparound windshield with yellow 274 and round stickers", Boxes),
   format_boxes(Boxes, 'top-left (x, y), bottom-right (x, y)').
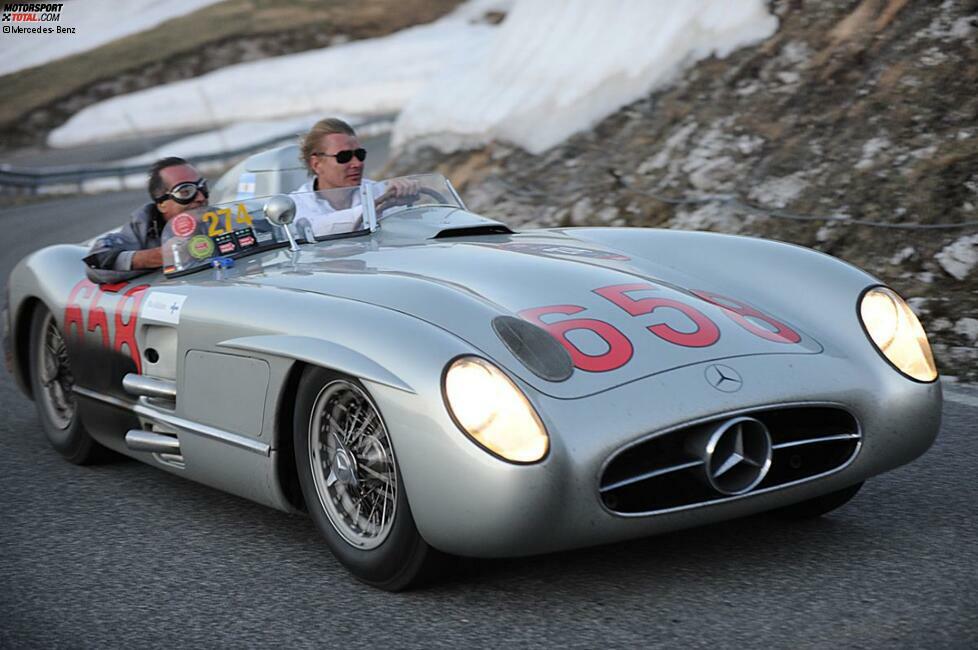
top-left (161, 174), bottom-right (465, 275)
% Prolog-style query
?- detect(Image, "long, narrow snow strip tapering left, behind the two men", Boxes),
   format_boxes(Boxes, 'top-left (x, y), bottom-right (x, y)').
top-left (48, 0), bottom-right (509, 147)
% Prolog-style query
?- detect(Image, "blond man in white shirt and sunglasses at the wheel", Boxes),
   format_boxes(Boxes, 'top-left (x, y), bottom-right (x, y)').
top-left (292, 117), bottom-right (417, 235)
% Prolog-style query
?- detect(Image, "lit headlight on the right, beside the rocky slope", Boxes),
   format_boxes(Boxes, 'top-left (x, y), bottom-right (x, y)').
top-left (859, 287), bottom-right (937, 381)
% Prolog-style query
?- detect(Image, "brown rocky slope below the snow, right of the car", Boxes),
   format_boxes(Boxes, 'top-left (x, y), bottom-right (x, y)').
top-left (389, 0), bottom-right (978, 381)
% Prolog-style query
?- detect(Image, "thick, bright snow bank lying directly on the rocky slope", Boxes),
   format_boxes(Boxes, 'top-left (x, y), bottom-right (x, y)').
top-left (393, 0), bottom-right (777, 153)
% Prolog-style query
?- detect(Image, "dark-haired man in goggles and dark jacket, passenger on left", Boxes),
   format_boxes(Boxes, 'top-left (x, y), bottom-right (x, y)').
top-left (85, 156), bottom-right (208, 282)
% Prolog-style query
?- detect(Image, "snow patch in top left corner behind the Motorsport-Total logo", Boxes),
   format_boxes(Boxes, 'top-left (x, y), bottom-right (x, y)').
top-left (0, 0), bottom-right (221, 75)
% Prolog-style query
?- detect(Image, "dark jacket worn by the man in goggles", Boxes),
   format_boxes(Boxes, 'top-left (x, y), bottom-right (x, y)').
top-left (85, 203), bottom-right (164, 283)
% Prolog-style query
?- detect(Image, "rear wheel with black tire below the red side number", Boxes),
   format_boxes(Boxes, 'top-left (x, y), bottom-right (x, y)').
top-left (29, 306), bottom-right (112, 465)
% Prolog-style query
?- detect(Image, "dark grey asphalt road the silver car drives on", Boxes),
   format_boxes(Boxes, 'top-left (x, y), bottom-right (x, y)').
top-left (0, 193), bottom-right (978, 650)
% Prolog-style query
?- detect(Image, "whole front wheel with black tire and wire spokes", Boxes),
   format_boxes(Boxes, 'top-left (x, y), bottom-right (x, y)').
top-left (293, 367), bottom-right (442, 591)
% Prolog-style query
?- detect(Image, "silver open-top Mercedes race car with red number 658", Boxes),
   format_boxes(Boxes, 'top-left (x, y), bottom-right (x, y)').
top-left (4, 148), bottom-right (941, 590)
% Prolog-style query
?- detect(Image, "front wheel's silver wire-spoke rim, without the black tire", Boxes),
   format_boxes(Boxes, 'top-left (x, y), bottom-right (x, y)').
top-left (308, 380), bottom-right (398, 550)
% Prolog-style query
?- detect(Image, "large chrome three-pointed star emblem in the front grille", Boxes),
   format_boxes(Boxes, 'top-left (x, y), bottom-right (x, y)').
top-left (704, 417), bottom-right (771, 495)
